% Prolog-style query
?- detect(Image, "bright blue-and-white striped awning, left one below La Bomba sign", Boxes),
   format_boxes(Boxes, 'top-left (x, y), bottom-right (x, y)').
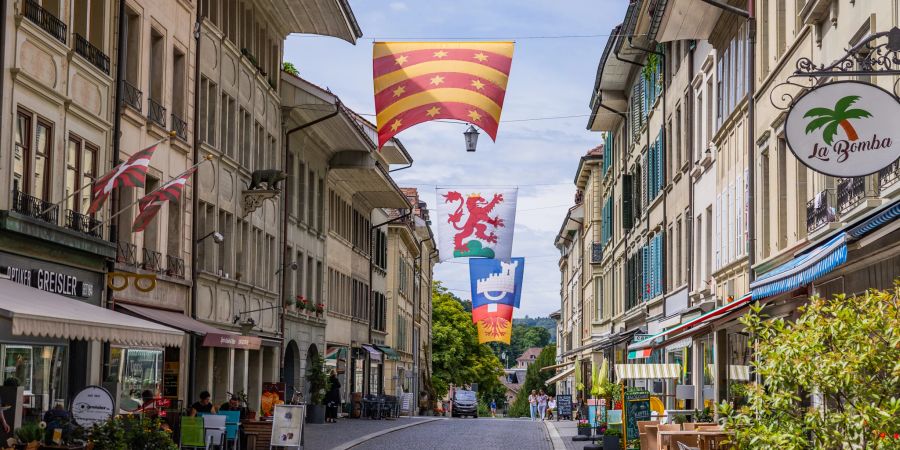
top-left (750, 233), bottom-right (848, 300)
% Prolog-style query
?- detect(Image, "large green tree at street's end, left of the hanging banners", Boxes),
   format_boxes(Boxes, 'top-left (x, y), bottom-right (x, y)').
top-left (431, 281), bottom-right (505, 402)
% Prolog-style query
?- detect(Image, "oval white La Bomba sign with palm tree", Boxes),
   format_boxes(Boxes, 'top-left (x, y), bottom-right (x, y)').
top-left (785, 81), bottom-right (900, 178)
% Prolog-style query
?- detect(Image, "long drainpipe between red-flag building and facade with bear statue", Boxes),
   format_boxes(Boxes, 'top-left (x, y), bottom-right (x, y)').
top-left (190, 16), bottom-right (203, 404)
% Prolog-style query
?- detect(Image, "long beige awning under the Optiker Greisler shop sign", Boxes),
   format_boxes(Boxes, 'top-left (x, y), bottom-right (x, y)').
top-left (0, 279), bottom-right (184, 347)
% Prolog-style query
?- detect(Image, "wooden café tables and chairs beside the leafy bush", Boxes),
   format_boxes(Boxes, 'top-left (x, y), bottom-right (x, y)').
top-left (638, 420), bottom-right (734, 450)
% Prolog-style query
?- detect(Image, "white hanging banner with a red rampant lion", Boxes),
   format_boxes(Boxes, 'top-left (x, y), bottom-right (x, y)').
top-left (437, 188), bottom-right (518, 261)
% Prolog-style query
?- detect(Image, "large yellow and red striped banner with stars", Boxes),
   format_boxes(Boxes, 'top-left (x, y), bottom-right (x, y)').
top-left (372, 42), bottom-right (514, 148)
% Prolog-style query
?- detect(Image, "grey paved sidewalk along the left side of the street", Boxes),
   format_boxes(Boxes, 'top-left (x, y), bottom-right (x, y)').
top-left (303, 417), bottom-right (437, 450)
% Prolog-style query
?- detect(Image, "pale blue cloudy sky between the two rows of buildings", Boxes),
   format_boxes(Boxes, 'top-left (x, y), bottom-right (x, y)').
top-left (284, 0), bottom-right (627, 317)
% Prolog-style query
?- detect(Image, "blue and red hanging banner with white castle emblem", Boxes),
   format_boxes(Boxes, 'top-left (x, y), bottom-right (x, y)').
top-left (469, 258), bottom-right (525, 308)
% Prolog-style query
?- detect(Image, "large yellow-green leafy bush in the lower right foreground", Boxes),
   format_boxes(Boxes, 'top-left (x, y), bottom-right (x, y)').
top-left (720, 285), bottom-right (900, 449)
